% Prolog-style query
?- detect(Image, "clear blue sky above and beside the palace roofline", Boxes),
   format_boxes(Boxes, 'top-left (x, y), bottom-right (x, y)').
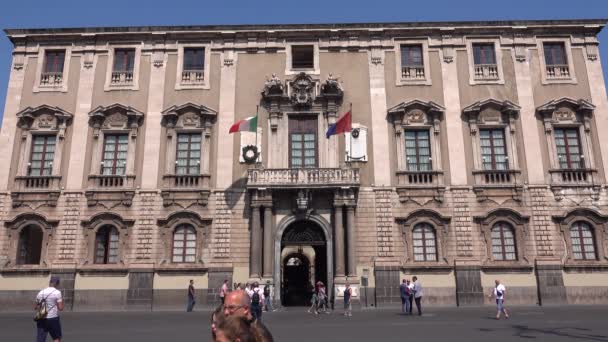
top-left (0, 0), bottom-right (608, 125)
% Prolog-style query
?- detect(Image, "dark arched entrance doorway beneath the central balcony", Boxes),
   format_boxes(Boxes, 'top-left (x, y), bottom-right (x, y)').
top-left (277, 220), bottom-right (331, 306)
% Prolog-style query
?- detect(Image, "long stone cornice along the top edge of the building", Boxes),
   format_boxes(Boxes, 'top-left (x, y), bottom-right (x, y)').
top-left (4, 19), bottom-right (608, 45)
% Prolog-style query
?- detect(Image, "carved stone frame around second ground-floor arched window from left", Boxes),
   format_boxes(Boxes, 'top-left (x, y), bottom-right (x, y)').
top-left (81, 212), bottom-right (135, 268)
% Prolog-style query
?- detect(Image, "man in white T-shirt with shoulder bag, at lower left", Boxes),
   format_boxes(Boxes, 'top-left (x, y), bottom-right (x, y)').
top-left (34, 277), bottom-right (63, 342)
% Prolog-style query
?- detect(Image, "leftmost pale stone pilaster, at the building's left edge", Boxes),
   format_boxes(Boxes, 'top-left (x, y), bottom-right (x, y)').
top-left (0, 46), bottom-right (27, 190)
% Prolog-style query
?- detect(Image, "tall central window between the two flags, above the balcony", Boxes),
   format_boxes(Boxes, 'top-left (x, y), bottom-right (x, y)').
top-left (289, 118), bottom-right (317, 168)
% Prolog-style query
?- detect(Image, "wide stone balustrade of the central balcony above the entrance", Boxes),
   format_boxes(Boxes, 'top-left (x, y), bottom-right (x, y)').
top-left (247, 168), bottom-right (360, 188)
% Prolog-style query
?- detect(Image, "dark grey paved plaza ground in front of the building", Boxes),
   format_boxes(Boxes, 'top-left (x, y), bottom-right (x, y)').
top-left (0, 306), bottom-right (608, 342)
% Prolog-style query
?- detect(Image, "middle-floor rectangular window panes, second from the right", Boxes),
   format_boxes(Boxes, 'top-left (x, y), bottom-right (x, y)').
top-left (479, 129), bottom-right (509, 170)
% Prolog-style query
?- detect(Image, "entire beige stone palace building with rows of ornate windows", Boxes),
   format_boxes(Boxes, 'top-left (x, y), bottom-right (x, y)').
top-left (0, 20), bottom-right (608, 310)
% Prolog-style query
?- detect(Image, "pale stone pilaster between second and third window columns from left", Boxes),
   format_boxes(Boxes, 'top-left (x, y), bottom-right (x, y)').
top-left (141, 43), bottom-right (165, 189)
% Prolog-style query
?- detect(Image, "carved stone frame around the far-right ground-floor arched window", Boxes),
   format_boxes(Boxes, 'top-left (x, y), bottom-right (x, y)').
top-left (553, 208), bottom-right (608, 265)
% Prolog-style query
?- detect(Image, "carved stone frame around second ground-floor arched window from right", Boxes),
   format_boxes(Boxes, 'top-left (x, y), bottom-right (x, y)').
top-left (473, 208), bottom-right (530, 266)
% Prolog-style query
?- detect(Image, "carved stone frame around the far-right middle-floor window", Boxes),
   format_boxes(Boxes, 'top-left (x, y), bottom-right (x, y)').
top-left (536, 97), bottom-right (596, 170)
